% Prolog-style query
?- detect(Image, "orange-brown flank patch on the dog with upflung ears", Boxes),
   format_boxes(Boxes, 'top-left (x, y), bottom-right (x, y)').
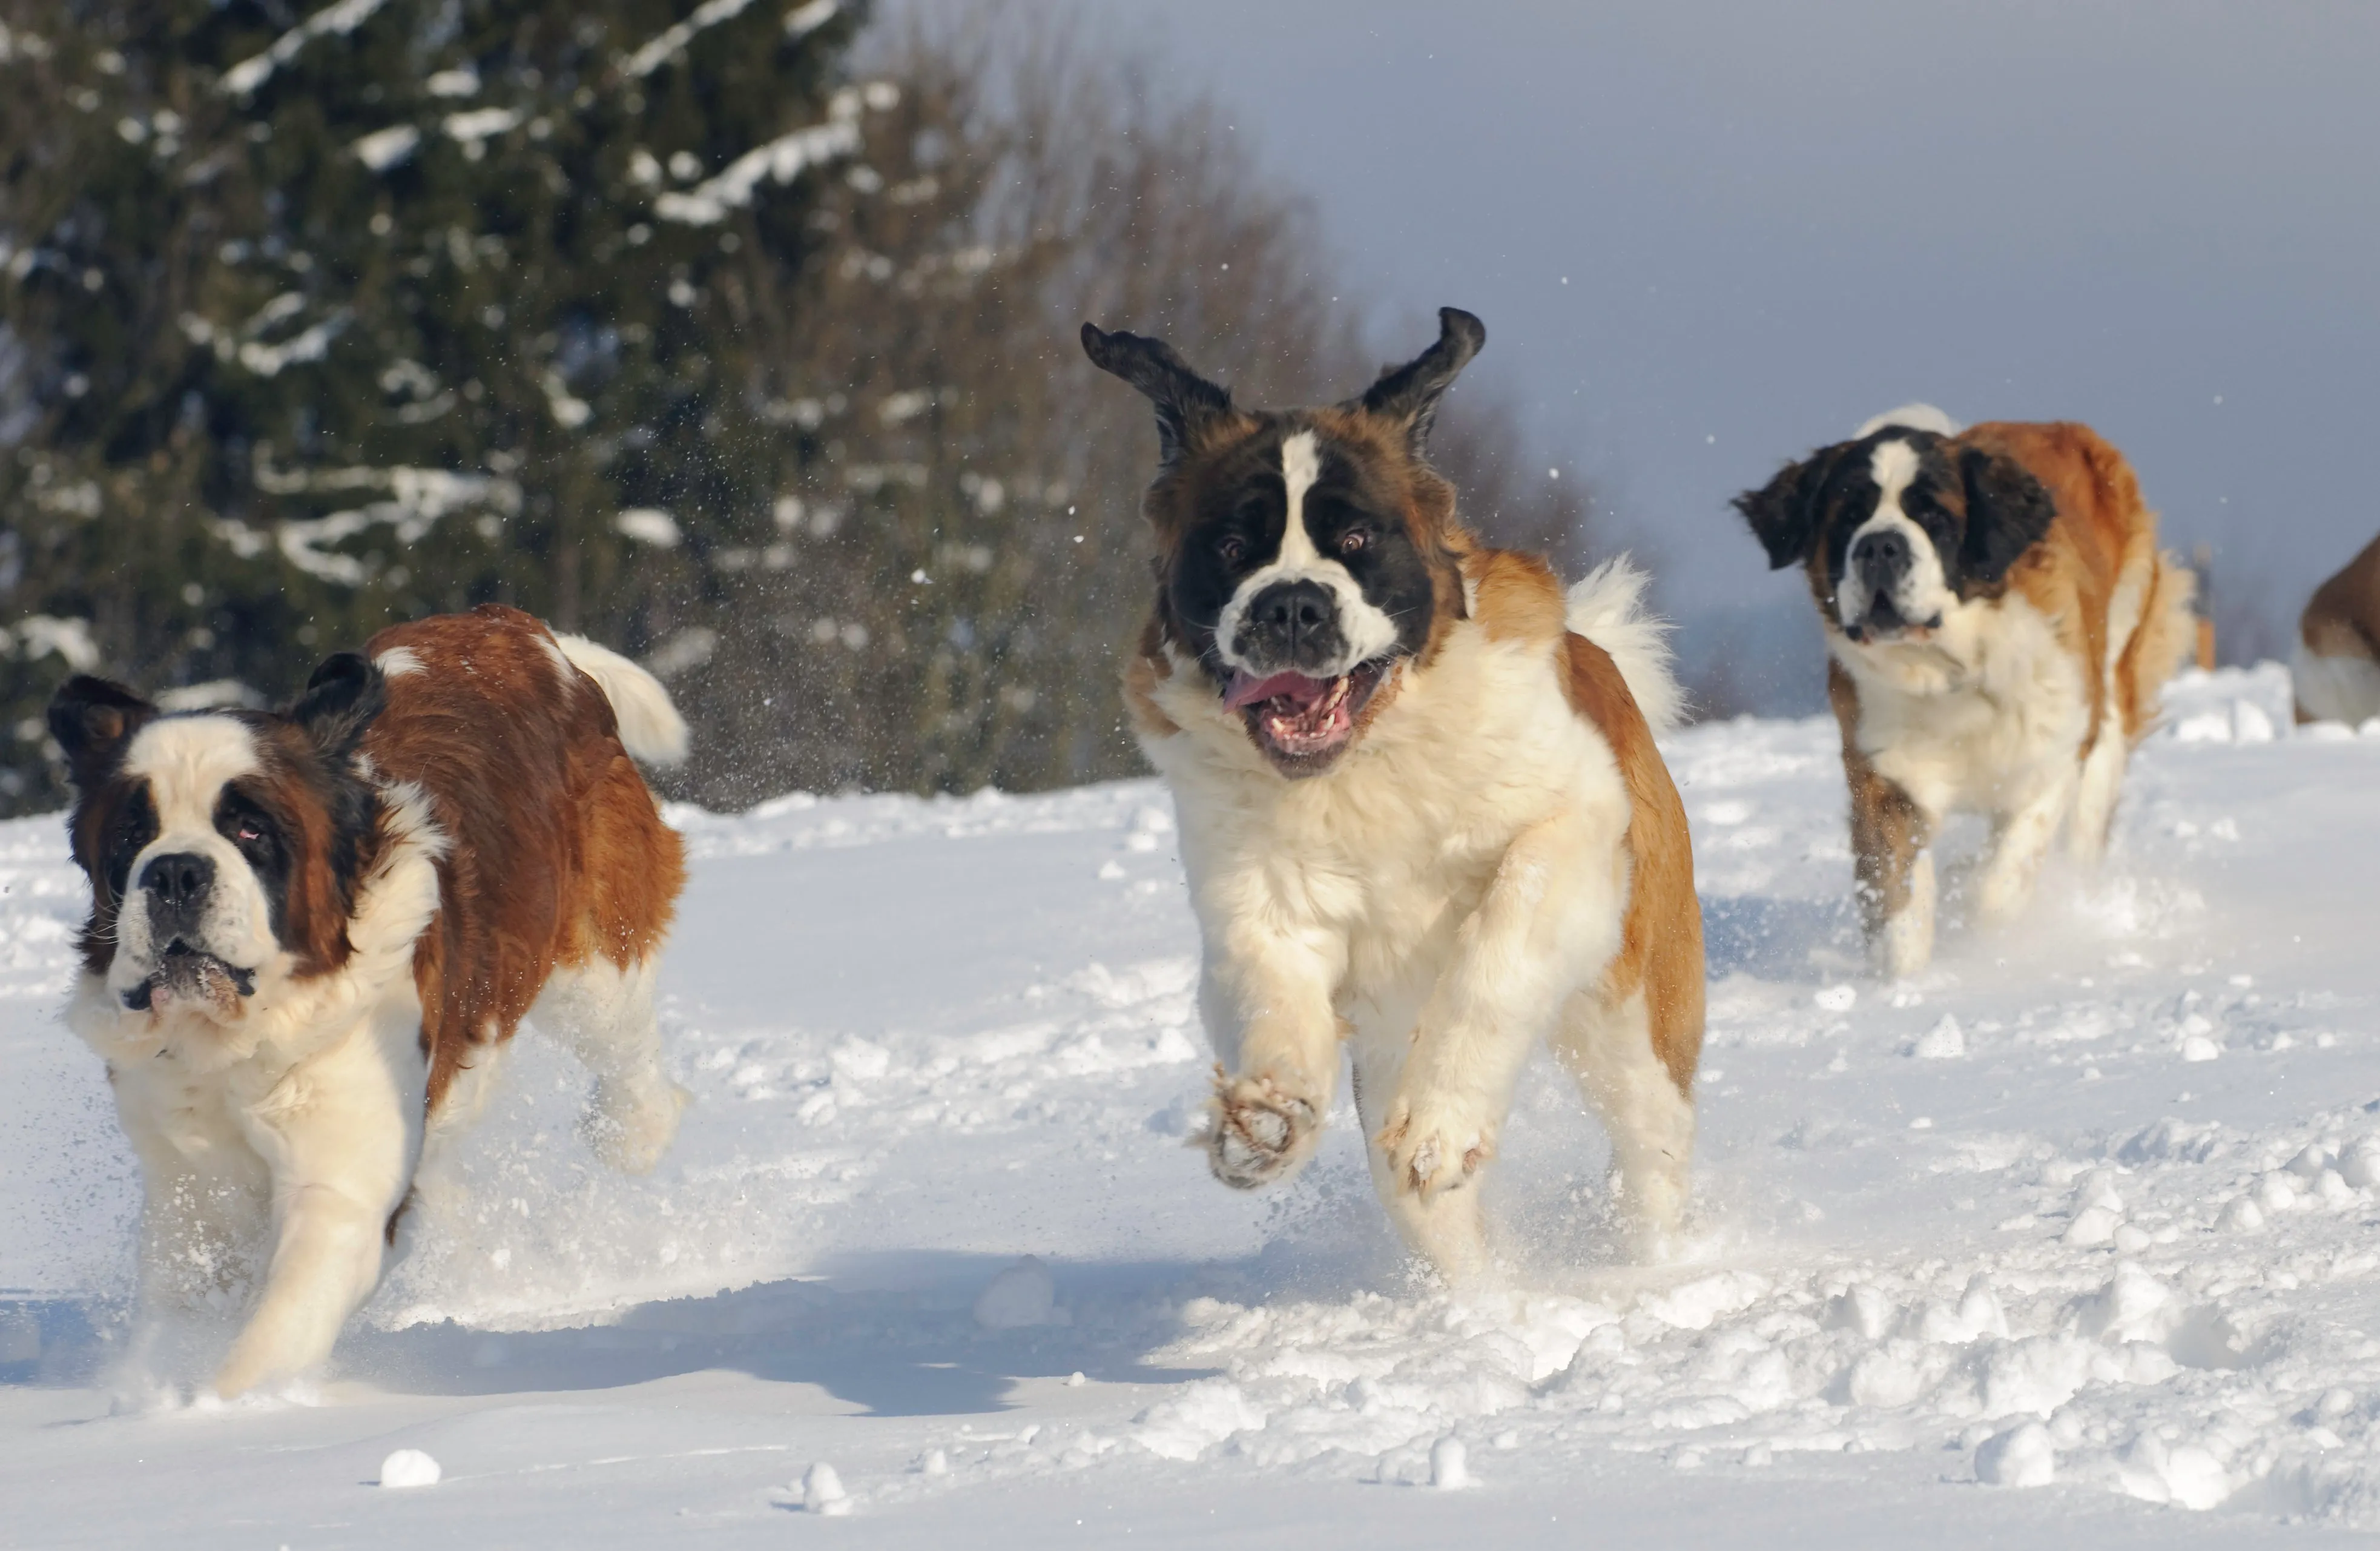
top-left (1571, 629), bottom-right (1704, 1096)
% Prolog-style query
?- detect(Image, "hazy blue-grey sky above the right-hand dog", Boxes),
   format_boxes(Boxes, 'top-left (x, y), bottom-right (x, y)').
top-left (1104, 0), bottom-right (2380, 693)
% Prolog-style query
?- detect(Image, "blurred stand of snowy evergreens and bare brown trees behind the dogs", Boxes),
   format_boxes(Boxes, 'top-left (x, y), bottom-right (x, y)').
top-left (0, 0), bottom-right (1590, 812)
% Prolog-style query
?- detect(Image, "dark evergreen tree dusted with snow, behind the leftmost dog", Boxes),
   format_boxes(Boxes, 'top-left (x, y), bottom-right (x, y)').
top-left (0, 0), bottom-right (871, 810)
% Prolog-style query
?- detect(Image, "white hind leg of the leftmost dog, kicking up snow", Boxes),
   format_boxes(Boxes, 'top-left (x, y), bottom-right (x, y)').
top-left (529, 957), bottom-right (693, 1174)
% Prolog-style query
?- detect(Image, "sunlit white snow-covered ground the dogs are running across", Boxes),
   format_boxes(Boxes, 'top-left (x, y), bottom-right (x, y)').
top-left (0, 667), bottom-right (2380, 1551)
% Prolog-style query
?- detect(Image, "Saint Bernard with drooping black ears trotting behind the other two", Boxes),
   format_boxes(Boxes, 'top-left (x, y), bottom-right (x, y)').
top-left (1735, 405), bottom-right (2194, 977)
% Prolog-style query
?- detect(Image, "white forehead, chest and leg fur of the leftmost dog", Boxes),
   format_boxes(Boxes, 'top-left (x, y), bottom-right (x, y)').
top-left (67, 757), bottom-right (685, 1396)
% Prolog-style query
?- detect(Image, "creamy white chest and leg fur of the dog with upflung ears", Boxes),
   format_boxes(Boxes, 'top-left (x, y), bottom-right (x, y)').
top-left (1145, 574), bottom-right (1690, 1280)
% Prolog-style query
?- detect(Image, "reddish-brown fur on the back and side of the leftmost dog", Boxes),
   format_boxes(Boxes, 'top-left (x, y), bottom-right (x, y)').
top-left (364, 605), bottom-right (685, 1110)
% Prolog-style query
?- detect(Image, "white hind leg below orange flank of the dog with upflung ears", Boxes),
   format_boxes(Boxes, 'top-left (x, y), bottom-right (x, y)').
top-left (1552, 991), bottom-right (1695, 1260)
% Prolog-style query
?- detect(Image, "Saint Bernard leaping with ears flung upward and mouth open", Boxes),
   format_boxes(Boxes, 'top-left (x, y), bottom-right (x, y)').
top-left (1083, 307), bottom-right (1702, 1281)
